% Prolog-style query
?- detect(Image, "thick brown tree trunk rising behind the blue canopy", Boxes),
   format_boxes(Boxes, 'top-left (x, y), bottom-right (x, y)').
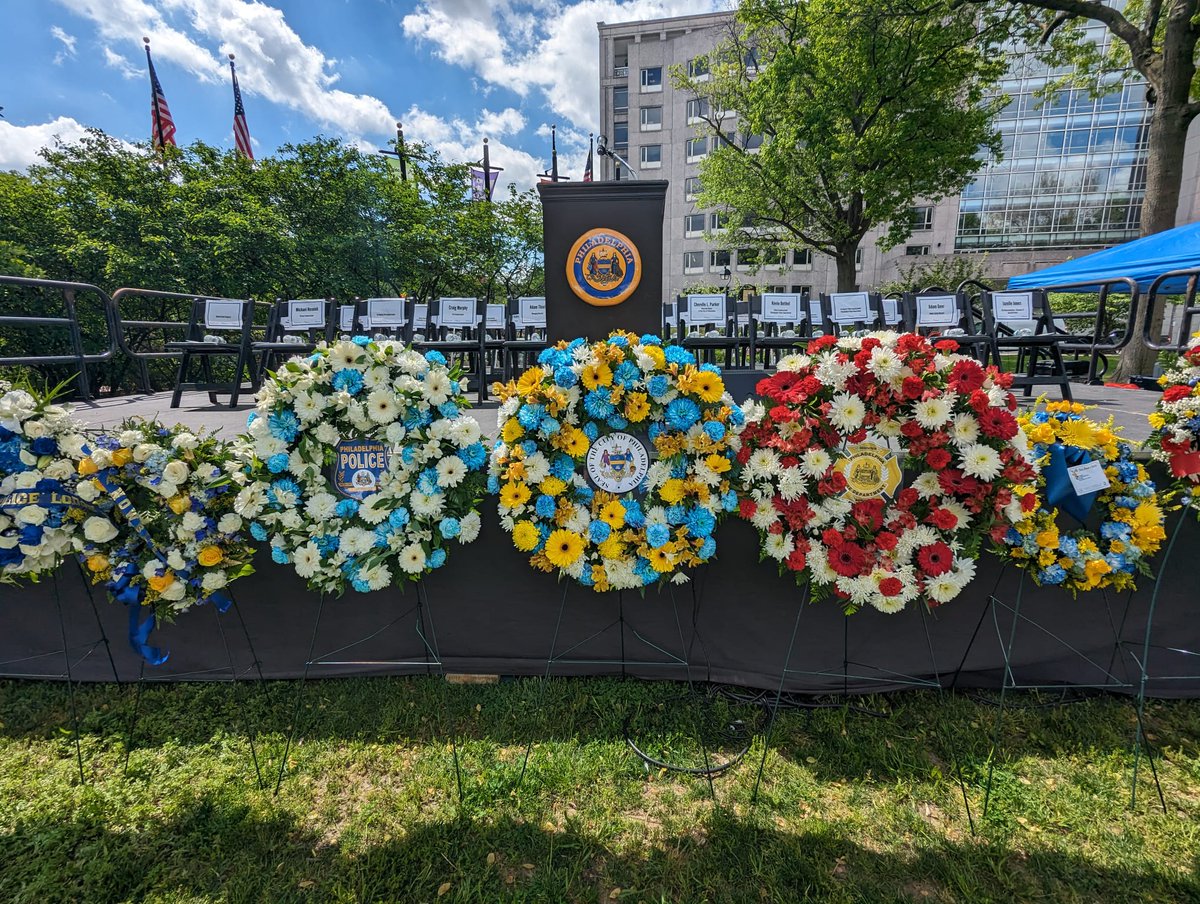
top-left (1114, 97), bottom-right (1192, 381)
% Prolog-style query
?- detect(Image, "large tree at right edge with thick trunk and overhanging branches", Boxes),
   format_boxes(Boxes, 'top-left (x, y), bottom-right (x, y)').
top-left (970, 0), bottom-right (1200, 379)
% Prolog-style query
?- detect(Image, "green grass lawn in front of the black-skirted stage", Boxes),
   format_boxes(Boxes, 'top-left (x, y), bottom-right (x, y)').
top-left (0, 678), bottom-right (1200, 904)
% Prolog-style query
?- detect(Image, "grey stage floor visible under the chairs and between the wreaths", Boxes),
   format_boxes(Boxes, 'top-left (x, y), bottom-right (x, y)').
top-left (76, 376), bottom-right (1158, 442)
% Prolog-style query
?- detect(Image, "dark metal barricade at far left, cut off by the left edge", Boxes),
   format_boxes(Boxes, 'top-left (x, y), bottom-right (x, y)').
top-left (0, 276), bottom-right (116, 400)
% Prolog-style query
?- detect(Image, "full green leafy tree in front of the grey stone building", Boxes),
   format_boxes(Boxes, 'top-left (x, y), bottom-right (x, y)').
top-left (672, 0), bottom-right (1006, 289)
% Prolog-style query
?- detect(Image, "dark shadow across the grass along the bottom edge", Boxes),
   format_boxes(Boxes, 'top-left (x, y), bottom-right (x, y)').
top-left (0, 797), bottom-right (1200, 904)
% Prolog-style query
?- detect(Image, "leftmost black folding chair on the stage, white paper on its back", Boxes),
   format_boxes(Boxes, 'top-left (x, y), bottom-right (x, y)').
top-left (167, 298), bottom-right (258, 408)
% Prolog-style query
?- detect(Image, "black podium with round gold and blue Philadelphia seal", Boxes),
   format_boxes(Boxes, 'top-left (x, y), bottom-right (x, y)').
top-left (538, 180), bottom-right (667, 342)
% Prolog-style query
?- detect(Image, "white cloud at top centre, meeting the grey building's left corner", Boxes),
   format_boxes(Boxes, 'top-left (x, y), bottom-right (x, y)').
top-left (401, 0), bottom-right (728, 131)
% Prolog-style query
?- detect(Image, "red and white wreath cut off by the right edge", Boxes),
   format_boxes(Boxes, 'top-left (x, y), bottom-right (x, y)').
top-left (1146, 333), bottom-right (1200, 501)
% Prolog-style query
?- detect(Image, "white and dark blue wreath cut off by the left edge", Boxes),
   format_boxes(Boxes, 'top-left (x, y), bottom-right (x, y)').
top-left (0, 381), bottom-right (96, 581)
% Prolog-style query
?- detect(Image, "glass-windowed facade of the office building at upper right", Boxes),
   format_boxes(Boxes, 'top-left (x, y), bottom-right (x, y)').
top-left (954, 29), bottom-right (1148, 251)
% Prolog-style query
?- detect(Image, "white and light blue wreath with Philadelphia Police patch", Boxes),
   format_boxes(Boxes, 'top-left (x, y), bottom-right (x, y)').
top-left (234, 336), bottom-right (487, 593)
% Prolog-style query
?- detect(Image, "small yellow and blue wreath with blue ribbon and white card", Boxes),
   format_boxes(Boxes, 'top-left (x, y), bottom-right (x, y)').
top-left (1000, 400), bottom-right (1166, 595)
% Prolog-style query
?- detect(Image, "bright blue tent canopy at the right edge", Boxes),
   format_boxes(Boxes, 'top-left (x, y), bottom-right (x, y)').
top-left (1008, 222), bottom-right (1200, 295)
